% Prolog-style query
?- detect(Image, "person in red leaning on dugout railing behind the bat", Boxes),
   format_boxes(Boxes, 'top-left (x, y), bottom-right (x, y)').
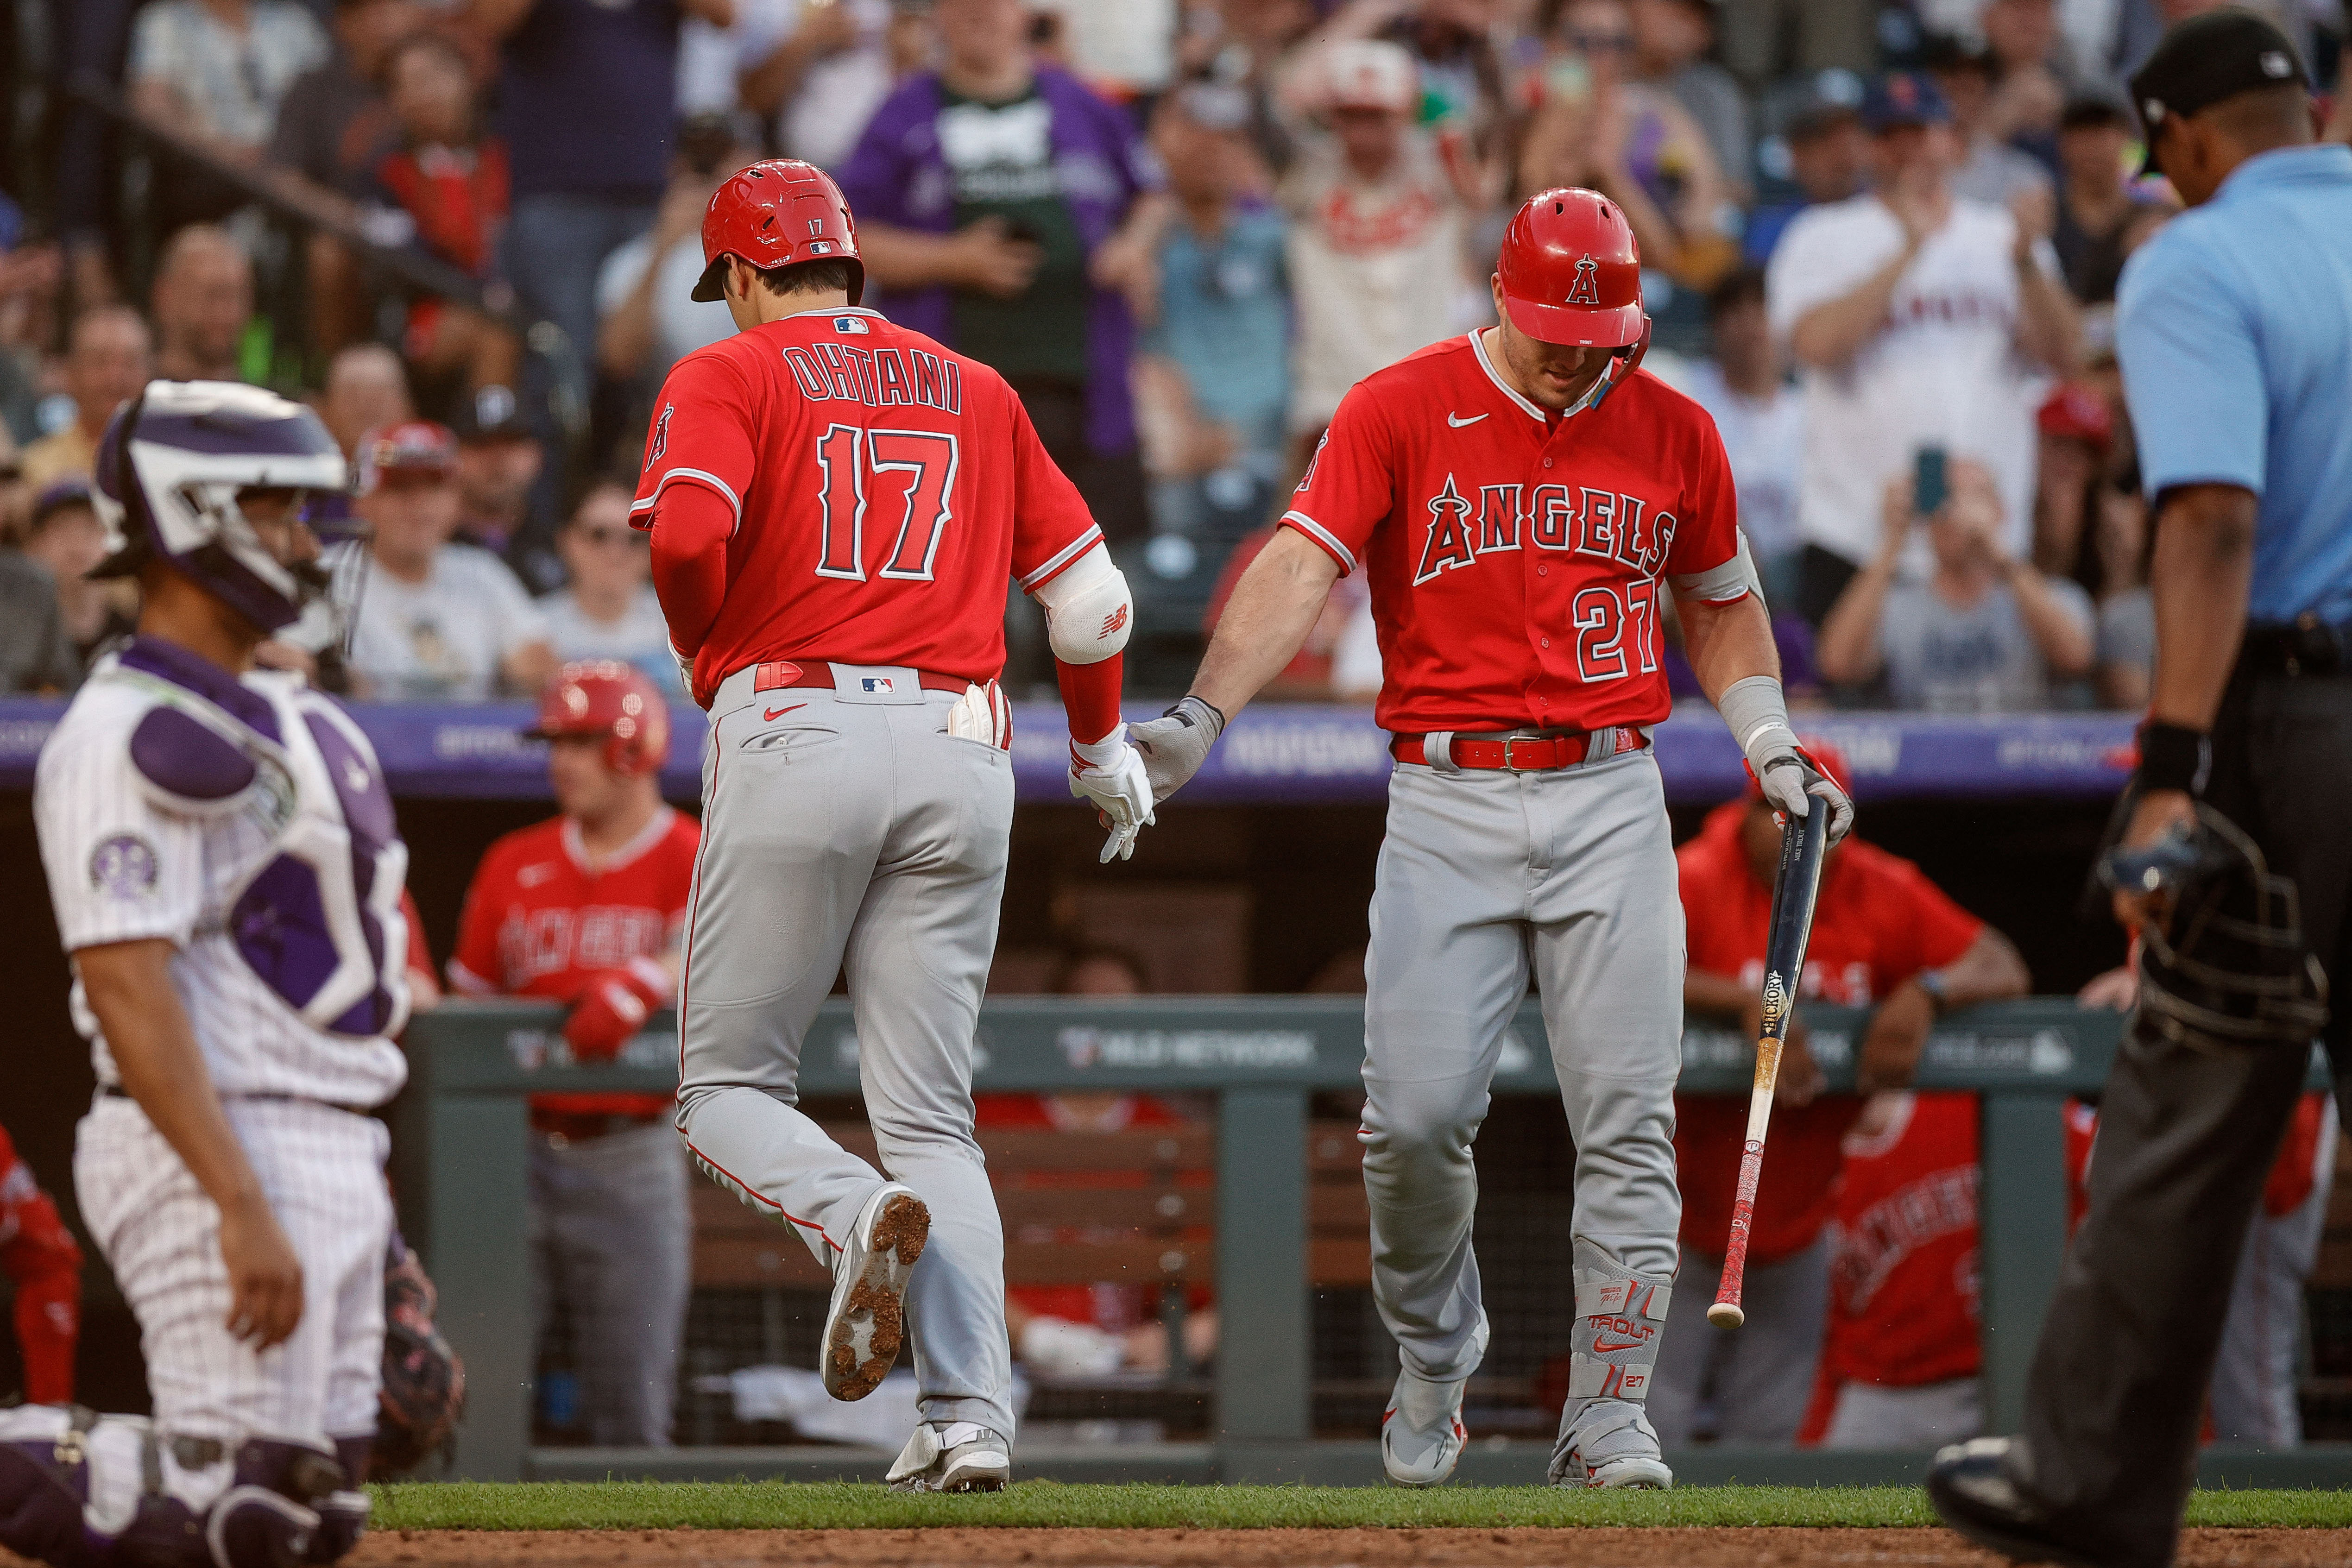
top-left (1649, 738), bottom-right (2030, 1446)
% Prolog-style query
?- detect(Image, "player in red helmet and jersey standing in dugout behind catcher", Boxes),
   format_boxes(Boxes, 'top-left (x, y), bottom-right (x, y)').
top-left (449, 658), bottom-right (701, 1448)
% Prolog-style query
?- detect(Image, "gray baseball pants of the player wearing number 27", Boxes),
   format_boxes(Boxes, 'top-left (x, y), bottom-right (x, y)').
top-left (1357, 752), bottom-right (1684, 1380)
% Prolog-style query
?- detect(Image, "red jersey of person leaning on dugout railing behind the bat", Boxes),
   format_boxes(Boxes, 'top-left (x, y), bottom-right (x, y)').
top-left (1675, 799), bottom-right (1985, 1265)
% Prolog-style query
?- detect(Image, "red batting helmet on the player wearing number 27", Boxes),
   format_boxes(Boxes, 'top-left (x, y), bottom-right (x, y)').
top-left (1496, 188), bottom-right (1649, 348)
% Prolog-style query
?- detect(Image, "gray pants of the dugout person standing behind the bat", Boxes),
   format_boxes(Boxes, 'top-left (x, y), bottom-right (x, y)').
top-left (1649, 1236), bottom-right (1830, 1446)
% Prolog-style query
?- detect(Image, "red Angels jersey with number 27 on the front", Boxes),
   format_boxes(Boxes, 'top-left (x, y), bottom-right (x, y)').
top-left (1282, 332), bottom-right (1745, 733)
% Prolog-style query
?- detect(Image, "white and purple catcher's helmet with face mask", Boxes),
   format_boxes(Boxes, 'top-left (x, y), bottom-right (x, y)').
top-left (89, 381), bottom-right (367, 649)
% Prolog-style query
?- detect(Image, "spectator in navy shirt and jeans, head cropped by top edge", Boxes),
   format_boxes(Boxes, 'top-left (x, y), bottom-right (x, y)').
top-left (466, 0), bottom-right (736, 411)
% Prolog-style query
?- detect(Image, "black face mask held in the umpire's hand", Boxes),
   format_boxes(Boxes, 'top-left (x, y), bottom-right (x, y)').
top-left (2098, 794), bottom-right (2328, 1048)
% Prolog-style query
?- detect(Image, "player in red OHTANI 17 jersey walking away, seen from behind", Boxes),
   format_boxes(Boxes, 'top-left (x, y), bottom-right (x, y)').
top-left (633, 162), bottom-right (1153, 1491)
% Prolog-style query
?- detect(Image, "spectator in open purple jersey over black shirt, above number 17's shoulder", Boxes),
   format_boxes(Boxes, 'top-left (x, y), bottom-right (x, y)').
top-left (839, 0), bottom-right (1173, 538)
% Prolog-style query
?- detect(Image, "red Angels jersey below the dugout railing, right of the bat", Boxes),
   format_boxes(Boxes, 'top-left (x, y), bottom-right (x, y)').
top-left (1823, 1093), bottom-right (1983, 1389)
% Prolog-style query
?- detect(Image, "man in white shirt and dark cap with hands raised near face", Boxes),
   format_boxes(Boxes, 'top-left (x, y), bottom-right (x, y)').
top-left (1764, 73), bottom-right (2079, 625)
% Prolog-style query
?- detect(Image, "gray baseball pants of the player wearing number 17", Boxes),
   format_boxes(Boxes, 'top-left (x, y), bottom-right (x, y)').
top-left (677, 665), bottom-right (1014, 1439)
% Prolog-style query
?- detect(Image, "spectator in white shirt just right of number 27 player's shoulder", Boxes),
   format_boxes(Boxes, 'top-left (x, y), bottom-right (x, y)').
top-left (1686, 265), bottom-right (1804, 611)
